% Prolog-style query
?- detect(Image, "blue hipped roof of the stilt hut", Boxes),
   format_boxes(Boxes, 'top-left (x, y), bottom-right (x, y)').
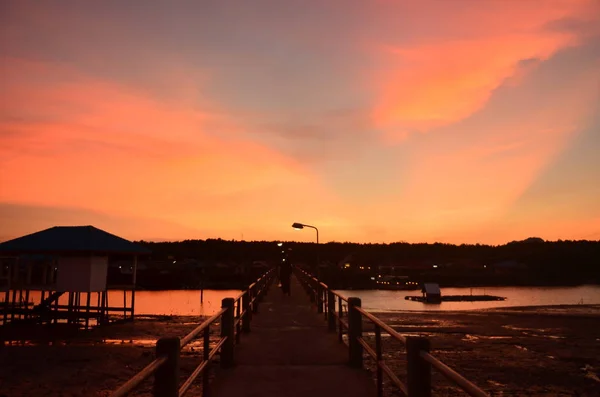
top-left (0, 226), bottom-right (150, 254)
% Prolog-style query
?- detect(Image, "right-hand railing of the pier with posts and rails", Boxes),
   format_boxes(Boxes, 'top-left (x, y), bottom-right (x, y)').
top-left (296, 269), bottom-right (488, 397)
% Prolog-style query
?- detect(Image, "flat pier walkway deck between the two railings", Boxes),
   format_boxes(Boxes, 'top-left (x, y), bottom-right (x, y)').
top-left (210, 277), bottom-right (377, 397)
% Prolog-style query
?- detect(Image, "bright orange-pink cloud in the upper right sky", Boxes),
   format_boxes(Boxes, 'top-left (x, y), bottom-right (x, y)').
top-left (371, 1), bottom-right (591, 140)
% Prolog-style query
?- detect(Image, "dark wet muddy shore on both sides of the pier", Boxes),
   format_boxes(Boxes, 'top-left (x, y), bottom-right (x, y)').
top-left (0, 305), bottom-right (600, 397)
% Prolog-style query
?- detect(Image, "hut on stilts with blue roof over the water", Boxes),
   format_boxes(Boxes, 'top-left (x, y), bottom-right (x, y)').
top-left (0, 226), bottom-right (150, 328)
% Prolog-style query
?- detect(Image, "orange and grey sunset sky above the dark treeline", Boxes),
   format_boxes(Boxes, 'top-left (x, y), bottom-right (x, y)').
top-left (0, 0), bottom-right (600, 244)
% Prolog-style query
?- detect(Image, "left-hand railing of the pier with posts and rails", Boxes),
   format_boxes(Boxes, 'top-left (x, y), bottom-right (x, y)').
top-left (111, 269), bottom-right (274, 397)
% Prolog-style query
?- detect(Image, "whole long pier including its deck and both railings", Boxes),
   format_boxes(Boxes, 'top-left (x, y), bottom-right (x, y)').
top-left (111, 269), bottom-right (489, 397)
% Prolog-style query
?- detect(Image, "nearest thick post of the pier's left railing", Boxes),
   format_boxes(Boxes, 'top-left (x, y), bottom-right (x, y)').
top-left (153, 338), bottom-right (180, 397)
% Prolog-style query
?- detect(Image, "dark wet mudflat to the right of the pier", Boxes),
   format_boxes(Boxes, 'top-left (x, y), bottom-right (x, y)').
top-left (364, 305), bottom-right (600, 397)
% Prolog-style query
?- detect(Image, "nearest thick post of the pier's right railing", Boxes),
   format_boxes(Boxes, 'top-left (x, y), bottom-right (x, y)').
top-left (406, 336), bottom-right (431, 397)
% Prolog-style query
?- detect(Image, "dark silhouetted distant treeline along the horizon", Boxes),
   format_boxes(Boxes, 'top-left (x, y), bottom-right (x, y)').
top-left (139, 237), bottom-right (600, 285)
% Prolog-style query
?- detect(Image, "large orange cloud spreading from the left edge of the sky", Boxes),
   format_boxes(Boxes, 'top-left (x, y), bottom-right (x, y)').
top-left (0, 59), bottom-right (328, 234)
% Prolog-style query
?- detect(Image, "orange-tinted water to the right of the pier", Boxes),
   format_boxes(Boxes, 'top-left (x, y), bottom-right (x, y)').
top-left (338, 285), bottom-right (600, 312)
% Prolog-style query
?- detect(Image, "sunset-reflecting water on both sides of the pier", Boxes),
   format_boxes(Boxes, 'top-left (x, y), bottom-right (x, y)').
top-left (8, 285), bottom-right (600, 316)
